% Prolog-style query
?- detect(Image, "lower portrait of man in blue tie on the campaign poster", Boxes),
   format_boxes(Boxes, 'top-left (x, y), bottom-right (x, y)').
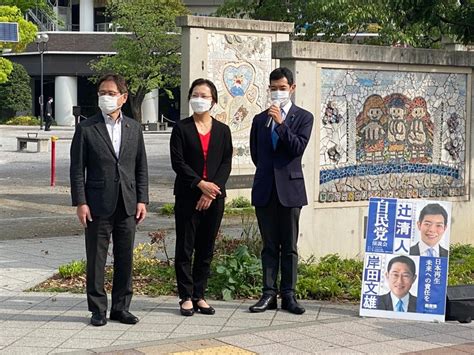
top-left (377, 255), bottom-right (418, 312)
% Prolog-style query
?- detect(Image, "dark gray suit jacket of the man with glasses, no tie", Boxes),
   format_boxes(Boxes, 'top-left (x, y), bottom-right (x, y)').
top-left (70, 112), bottom-right (148, 217)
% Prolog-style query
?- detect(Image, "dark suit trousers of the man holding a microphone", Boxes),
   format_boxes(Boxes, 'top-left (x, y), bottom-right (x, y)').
top-left (255, 183), bottom-right (301, 297)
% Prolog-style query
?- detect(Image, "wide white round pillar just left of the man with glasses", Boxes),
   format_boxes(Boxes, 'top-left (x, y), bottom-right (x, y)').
top-left (54, 76), bottom-right (77, 126)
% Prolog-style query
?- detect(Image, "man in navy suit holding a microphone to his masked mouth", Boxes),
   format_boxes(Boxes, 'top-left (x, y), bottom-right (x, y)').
top-left (250, 68), bottom-right (313, 314)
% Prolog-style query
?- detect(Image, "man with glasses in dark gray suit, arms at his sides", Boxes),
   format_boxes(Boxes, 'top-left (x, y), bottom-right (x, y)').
top-left (70, 74), bottom-right (148, 326)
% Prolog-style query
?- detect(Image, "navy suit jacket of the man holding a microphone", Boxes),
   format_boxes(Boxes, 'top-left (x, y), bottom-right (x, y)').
top-left (250, 104), bottom-right (313, 207)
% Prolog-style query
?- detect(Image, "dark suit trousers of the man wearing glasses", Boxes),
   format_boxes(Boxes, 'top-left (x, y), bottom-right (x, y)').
top-left (86, 192), bottom-right (136, 312)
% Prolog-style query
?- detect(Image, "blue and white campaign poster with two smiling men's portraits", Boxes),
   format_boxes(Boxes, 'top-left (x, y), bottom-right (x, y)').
top-left (360, 198), bottom-right (451, 322)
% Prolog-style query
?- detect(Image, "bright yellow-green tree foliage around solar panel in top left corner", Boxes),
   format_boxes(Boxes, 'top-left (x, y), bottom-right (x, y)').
top-left (0, 5), bottom-right (37, 84)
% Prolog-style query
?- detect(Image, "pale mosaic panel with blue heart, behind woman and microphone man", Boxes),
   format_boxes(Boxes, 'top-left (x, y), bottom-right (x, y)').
top-left (207, 33), bottom-right (272, 166)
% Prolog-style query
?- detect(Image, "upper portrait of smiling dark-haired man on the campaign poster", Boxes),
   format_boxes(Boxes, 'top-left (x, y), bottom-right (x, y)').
top-left (410, 202), bottom-right (450, 258)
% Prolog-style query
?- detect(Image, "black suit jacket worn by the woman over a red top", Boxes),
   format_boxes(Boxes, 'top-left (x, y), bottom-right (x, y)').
top-left (170, 116), bottom-right (233, 199)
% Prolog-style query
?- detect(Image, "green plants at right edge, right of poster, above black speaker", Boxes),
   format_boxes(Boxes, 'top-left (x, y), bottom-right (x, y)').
top-left (448, 244), bottom-right (474, 286)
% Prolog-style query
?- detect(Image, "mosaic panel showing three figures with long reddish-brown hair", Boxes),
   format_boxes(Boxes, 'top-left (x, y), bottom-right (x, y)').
top-left (319, 69), bottom-right (467, 202)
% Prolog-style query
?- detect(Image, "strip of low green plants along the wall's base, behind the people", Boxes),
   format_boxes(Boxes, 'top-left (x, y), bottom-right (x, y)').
top-left (30, 241), bottom-right (474, 303)
